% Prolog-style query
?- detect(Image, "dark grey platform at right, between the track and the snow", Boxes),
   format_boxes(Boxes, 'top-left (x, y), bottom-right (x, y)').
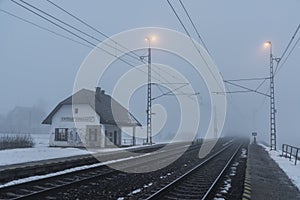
top-left (243, 144), bottom-right (300, 200)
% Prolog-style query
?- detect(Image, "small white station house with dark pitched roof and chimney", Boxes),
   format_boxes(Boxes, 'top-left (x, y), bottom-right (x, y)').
top-left (42, 87), bottom-right (141, 148)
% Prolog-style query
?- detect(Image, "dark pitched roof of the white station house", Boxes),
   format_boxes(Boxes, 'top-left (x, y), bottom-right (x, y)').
top-left (42, 89), bottom-right (141, 126)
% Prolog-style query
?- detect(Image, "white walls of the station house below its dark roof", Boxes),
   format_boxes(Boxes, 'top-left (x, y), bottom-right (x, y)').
top-left (49, 104), bottom-right (122, 147)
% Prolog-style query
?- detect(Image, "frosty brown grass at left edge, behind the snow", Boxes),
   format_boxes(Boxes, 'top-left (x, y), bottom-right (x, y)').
top-left (0, 134), bottom-right (34, 150)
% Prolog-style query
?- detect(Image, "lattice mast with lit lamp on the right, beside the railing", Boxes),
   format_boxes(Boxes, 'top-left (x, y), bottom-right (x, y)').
top-left (264, 41), bottom-right (280, 150)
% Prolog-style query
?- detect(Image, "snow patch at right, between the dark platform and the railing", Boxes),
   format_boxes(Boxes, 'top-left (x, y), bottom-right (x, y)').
top-left (260, 144), bottom-right (300, 190)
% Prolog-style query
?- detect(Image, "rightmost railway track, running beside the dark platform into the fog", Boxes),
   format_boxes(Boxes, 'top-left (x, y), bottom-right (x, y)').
top-left (146, 142), bottom-right (241, 200)
